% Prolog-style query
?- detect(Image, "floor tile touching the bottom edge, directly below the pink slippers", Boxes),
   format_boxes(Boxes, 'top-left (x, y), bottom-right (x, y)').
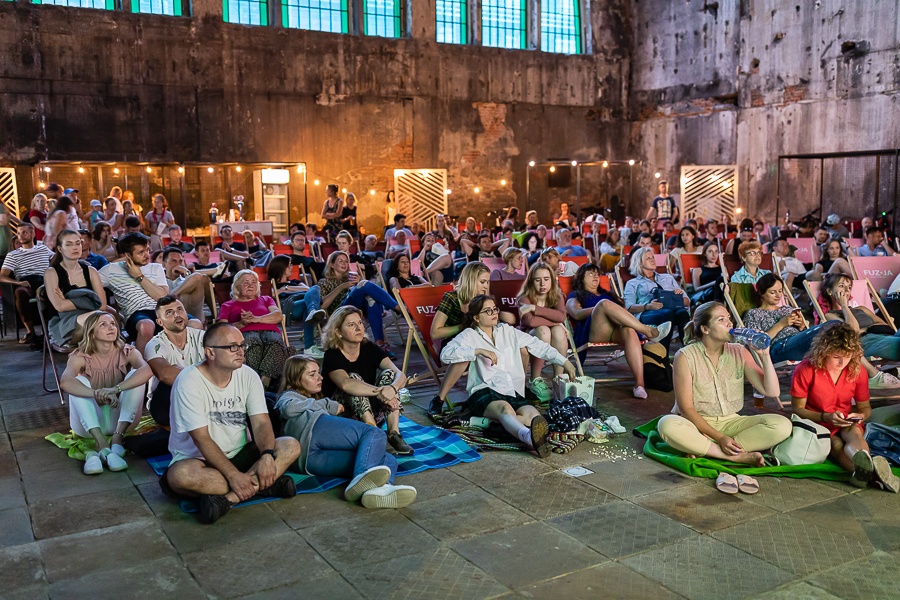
top-left (621, 536), bottom-right (794, 600)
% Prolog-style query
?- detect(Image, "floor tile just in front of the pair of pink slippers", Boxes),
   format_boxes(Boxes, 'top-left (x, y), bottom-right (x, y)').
top-left (633, 480), bottom-right (774, 533)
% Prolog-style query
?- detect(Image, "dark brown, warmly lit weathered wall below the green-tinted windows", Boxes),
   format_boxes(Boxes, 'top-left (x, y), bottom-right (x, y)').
top-left (0, 0), bottom-right (629, 229)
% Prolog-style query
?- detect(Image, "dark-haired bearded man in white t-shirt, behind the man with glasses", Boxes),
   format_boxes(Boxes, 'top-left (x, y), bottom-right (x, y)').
top-left (144, 295), bottom-right (204, 426)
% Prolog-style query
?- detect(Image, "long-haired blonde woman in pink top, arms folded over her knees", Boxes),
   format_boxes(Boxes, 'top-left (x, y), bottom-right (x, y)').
top-left (519, 262), bottom-right (569, 402)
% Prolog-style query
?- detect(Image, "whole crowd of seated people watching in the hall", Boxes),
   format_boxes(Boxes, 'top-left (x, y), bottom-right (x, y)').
top-left (10, 186), bottom-right (900, 523)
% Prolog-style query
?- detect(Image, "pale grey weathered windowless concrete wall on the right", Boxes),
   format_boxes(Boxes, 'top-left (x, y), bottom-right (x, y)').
top-left (629, 0), bottom-right (900, 219)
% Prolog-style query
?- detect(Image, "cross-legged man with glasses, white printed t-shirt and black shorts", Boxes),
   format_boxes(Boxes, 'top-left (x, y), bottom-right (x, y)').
top-left (160, 323), bottom-right (300, 523)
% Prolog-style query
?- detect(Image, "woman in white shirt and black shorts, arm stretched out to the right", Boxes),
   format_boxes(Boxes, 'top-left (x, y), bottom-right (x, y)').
top-left (441, 294), bottom-right (575, 458)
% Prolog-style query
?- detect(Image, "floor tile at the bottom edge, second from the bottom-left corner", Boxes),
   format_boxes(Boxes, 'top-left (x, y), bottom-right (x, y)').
top-left (50, 558), bottom-right (206, 600)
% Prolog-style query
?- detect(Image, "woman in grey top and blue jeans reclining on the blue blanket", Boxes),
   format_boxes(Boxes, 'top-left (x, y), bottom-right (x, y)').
top-left (275, 355), bottom-right (416, 508)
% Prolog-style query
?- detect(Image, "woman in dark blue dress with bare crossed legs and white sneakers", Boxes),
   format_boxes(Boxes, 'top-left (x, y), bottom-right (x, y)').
top-left (566, 262), bottom-right (672, 399)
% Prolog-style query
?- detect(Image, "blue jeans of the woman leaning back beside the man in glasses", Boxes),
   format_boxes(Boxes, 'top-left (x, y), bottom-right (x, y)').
top-left (306, 415), bottom-right (397, 483)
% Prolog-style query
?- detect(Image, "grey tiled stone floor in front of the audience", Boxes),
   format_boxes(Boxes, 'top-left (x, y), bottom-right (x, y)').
top-left (0, 330), bottom-right (900, 600)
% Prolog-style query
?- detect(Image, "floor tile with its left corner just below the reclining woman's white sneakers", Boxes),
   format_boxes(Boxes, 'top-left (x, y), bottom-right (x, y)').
top-left (402, 489), bottom-right (533, 541)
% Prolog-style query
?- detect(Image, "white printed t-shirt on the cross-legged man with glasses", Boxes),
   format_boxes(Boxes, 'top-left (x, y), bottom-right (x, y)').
top-left (169, 365), bottom-right (269, 462)
